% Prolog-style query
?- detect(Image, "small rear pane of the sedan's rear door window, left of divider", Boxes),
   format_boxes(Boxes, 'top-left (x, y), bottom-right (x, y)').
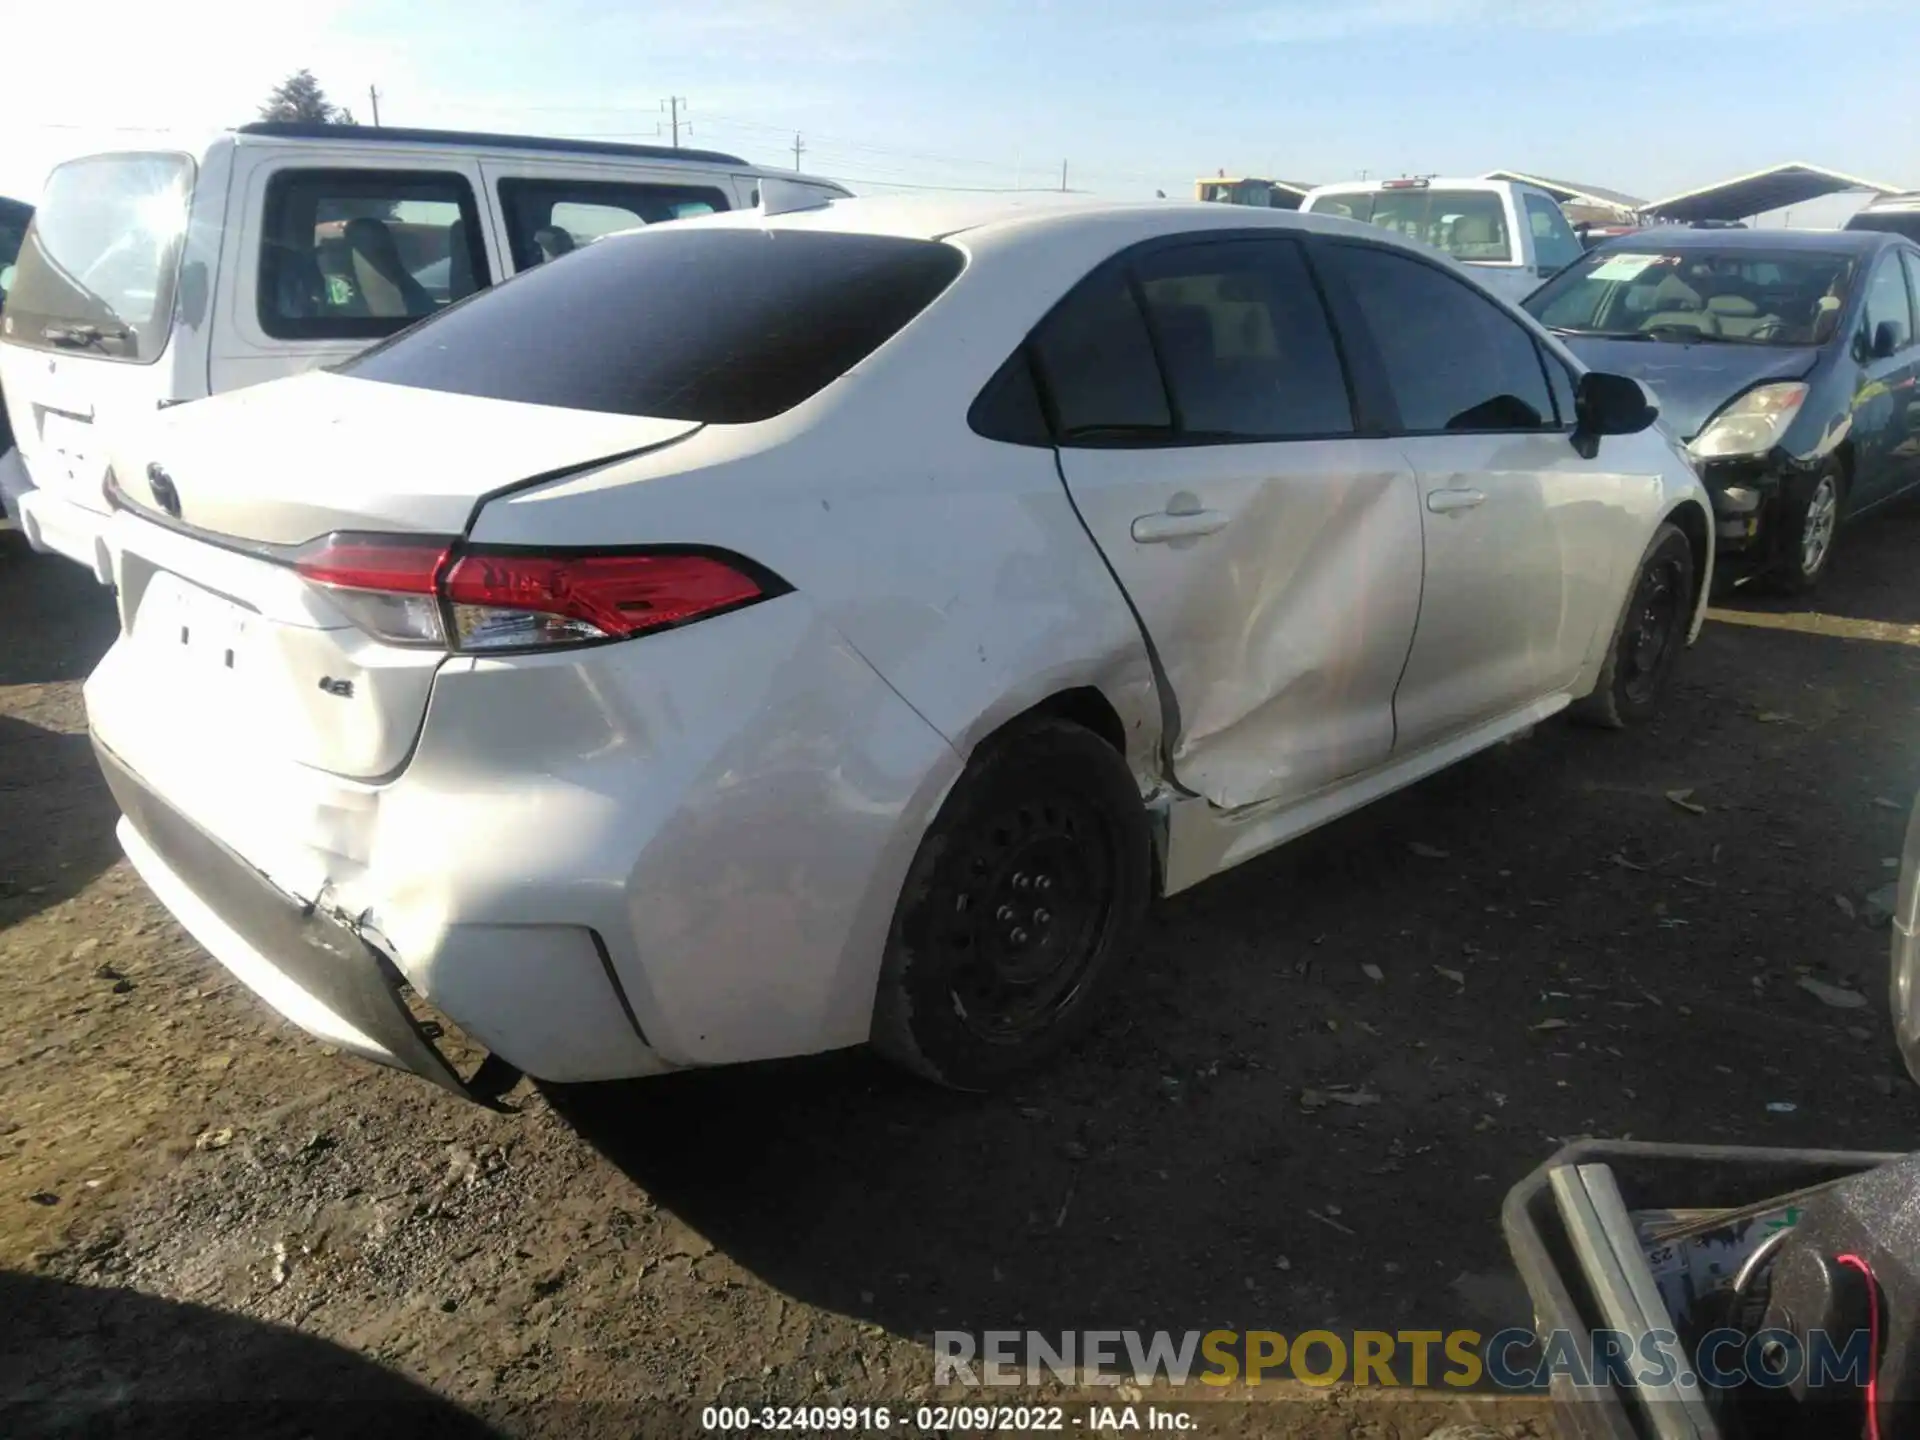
top-left (1033, 267), bottom-right (1173, 445)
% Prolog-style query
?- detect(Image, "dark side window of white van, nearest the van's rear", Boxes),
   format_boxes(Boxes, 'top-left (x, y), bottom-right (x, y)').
top-left (257, 169), bottom-right (490, 340)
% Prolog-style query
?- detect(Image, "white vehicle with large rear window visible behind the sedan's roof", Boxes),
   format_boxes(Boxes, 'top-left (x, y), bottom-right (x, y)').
top-left (1300, 179), bottom-right (1586, 303)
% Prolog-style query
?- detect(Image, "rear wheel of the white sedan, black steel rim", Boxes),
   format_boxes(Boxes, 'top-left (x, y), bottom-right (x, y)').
top-left (872, 720), bottom-right (1154, 1091)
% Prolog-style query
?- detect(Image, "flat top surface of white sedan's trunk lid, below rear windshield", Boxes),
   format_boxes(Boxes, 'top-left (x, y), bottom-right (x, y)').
top-left (115, 372), bottom-right (699, 545)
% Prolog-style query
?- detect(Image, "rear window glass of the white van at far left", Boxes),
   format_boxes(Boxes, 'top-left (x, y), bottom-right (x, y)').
top-left (0, 156), bottom-right (194, 365)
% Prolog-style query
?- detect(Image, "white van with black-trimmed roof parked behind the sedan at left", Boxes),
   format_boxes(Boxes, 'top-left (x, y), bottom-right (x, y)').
top-left (0, 123), bottom-right (849, 584)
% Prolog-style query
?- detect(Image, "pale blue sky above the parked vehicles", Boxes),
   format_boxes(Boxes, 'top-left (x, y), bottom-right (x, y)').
top-left (0, 0), bottom-right (1920, 225)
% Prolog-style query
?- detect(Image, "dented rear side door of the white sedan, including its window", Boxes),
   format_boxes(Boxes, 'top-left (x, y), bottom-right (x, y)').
top-left (1035, 238), bottom-right (1421, 808)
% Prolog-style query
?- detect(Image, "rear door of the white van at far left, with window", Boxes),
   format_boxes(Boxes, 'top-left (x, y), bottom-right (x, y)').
top-left (0, 154), bottom-right (196, 570)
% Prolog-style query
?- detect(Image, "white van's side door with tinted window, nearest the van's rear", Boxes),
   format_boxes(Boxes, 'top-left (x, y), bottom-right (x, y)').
top-left (207, 146), bottom-right (503, 394)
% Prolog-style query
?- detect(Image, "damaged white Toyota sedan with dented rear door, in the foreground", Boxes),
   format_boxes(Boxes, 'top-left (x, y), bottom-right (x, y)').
top-left (86, 189), bottom-right (1713, 1094)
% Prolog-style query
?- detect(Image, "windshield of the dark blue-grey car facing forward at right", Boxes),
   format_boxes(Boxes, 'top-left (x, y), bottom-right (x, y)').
top-left (1524, 244), bottom-right (1855, 346)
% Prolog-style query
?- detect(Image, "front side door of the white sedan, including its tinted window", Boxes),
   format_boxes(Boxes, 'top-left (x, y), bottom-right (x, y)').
top-left (1317, 242), bottom-right (1626, 751)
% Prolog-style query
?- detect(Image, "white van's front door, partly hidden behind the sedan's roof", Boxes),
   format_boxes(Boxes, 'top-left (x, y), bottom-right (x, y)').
top-left (482, 156), bottom-right (733, 271)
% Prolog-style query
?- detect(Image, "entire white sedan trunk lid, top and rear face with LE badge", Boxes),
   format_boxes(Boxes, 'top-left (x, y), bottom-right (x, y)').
top-left (86, 374), bottom-right (699, 794)
